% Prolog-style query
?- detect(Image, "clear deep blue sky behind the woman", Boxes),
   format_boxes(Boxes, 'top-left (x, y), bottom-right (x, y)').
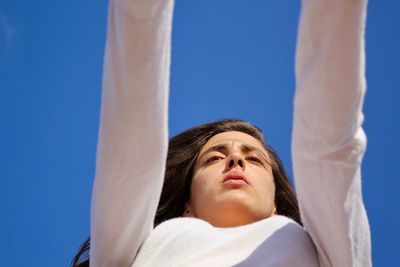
top-left (0, 0), bottom-right (400, 266)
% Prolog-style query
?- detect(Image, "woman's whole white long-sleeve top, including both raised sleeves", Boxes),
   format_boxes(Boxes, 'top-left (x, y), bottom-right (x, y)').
top-left (90, 0), bottom-right (371, 267)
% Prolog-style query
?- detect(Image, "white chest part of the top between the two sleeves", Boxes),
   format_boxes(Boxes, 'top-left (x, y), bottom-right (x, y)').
top-left (132, 216), bottom-right (319, 267)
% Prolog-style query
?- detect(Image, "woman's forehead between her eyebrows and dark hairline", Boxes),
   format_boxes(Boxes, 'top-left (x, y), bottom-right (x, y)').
top-left (200, 131), bottom-right (268, 154)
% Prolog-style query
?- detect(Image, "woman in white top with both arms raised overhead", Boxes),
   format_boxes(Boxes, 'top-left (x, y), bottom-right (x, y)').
top-left (72, 0), bottom-right (371, 266)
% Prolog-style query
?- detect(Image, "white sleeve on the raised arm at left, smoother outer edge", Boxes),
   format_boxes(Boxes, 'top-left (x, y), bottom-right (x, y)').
top-left (90, 0), bottom-right (173, 266)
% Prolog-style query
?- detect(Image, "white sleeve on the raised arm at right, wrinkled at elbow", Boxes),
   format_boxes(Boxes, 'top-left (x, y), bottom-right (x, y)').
top-left (292, 0), bottom-right (371, 267)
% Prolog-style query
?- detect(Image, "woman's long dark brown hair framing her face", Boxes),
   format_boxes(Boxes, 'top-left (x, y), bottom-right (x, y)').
top-left (72, 119), bottom-right (302, 267)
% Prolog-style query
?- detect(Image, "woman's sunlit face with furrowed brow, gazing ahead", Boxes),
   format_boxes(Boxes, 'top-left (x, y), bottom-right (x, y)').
top-left (186, 131), bottom-right (275, 227)
